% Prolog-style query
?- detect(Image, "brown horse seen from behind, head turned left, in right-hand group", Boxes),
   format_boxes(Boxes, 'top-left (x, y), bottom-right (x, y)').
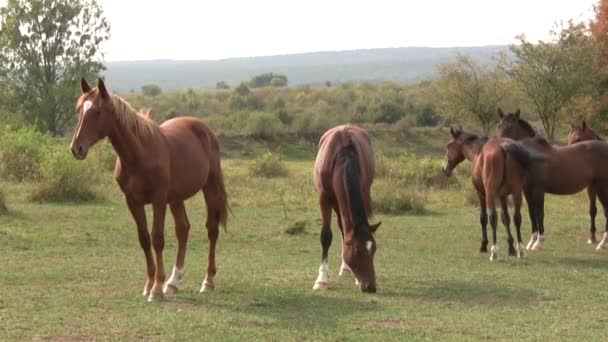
top-left (442, 128), bottom-right (537, 261)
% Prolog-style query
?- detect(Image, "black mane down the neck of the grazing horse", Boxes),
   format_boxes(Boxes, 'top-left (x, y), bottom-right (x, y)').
top-left (338, 142), bottom-right (369, 235)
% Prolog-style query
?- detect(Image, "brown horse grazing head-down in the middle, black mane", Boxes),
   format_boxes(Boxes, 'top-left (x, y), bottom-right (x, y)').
top-left (313, 125), bottom-right (380, 292)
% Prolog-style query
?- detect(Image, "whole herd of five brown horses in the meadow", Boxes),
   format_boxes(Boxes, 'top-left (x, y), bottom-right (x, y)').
top-left (70, 78), bottom-right (608, 301)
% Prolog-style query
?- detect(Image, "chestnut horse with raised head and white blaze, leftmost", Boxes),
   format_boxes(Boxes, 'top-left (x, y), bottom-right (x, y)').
top-left (70, 78), bottom-right (228, 301)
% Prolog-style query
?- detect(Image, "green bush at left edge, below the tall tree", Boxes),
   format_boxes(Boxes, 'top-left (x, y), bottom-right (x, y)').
top-left (0, 127), bottom-right (49, 182)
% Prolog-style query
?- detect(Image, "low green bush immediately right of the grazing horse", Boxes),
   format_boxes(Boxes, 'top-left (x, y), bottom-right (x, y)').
top-left (372, 181), bottom-right (427, 215)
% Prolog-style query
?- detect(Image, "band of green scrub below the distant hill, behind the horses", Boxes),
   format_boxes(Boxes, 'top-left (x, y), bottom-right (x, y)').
top-left (124, 81), bottom-right (441, 139)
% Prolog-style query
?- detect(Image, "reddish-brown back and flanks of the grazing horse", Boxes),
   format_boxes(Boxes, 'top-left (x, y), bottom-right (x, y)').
top-left (314, 124), bottom-right (375, 192)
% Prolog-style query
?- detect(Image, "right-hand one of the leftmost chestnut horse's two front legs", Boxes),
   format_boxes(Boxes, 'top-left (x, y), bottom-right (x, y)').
top-left (148, 196), bottom-right (167, 302)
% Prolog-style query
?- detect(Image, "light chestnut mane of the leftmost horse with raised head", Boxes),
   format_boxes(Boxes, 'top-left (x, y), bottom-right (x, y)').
top-left (112, 95), bottom-right (160, 138)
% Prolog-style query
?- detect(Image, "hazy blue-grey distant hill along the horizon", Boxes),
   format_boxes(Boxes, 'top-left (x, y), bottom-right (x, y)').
top-left (105, 45), bottom-right (509, 92)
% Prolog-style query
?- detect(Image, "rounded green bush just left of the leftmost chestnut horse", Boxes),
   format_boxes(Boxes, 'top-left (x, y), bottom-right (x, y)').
top-left (30, 151), bottom-right (99, 202)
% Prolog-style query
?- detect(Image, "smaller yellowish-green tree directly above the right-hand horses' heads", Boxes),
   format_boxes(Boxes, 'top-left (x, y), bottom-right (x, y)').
top-left (437, 55), bottom-right (508, 134)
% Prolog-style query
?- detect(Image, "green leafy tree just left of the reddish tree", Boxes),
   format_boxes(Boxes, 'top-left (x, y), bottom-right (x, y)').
top-left (510, 21), bottom-right (598, 141)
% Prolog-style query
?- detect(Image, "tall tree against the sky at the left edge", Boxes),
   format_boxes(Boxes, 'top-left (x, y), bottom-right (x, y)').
top-left (0, 0), bottom-right (110, 135)
